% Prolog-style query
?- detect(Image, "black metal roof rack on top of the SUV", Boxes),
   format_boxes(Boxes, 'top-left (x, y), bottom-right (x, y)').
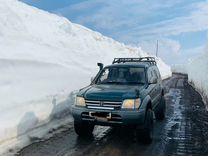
top-left (112, 57), bottom-right (156, 65)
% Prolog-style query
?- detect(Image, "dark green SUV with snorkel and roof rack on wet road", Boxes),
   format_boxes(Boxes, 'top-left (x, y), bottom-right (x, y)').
top-left (72, 57), bottom-right (165, 143)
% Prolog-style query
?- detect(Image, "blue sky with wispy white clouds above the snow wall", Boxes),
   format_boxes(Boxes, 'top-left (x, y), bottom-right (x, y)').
top-left (21, 0), bottom-right (208, 65)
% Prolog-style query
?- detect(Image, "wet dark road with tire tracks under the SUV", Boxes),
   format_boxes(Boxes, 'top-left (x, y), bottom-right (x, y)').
top-left (18, 74), bottom-right (208, 156)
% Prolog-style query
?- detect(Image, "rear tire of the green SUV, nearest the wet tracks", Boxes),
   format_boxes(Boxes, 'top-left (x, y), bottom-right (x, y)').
top-left (155, 96), bottom-right (166, 120)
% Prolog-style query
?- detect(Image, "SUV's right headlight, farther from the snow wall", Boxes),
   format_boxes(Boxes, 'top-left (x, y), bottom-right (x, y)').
top-left (122, 99), bottom-right (141, 109)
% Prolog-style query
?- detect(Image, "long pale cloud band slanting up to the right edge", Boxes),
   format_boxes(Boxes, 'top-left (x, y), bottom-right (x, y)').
top-left (120, 2), bottom-right (208, 40)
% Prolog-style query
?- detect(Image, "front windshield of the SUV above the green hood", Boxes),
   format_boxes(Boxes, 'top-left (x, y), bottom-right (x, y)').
top-left (96, 67), bottom-right (146, 84)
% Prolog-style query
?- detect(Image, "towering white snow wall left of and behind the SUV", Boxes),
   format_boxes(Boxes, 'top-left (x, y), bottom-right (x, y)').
top-left (0, 0), bottom-right (171, 154)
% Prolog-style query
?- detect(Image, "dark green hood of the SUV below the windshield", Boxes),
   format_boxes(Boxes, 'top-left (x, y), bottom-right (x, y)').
top-left (80, 85), bottom-right (144, 101)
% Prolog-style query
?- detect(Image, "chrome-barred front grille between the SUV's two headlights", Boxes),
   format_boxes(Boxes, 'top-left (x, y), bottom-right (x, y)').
top-left (85, 100), bottom-right (122, 110)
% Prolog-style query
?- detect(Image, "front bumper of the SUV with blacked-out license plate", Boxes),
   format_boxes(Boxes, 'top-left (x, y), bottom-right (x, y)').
top-left (72, 106), bottom-right (145, 126)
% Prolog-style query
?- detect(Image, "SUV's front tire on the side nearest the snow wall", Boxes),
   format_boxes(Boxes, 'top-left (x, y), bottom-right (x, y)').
top-left (74, 121), bottom-right (95, 137)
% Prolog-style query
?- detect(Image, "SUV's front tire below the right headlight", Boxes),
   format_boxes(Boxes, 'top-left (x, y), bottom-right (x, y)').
top-left (137, 109), bottom-right (154, 144)
